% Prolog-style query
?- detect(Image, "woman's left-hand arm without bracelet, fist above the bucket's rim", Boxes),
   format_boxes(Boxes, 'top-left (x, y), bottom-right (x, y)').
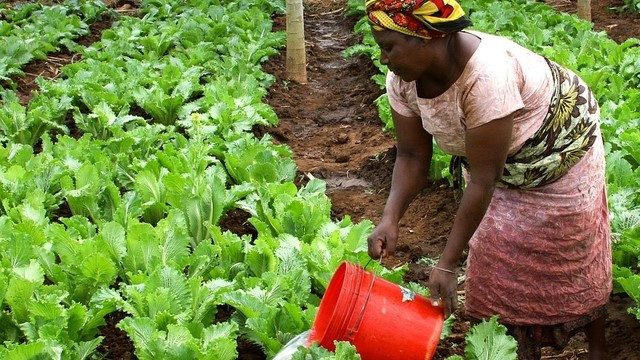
top-left (368, 110), bottom-right (433, 259)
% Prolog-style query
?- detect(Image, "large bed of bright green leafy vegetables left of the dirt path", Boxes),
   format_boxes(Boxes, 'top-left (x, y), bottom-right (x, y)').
top-left (0, 0), bottom-right (410, 360)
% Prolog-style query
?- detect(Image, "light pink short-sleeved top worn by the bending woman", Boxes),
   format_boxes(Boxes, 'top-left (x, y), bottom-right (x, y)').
top-left (387, 31), bottom-right (553, 156)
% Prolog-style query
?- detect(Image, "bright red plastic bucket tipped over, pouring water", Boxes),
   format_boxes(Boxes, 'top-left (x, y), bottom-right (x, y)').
top-left (307, 262), bottom-right (444, 360)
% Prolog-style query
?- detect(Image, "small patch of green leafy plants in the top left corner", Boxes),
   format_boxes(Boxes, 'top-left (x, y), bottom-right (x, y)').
top-left (0, 0), bottom-right (107, 83)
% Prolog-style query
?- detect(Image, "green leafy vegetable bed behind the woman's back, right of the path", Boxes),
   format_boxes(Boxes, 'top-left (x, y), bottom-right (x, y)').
top-left (346, 0), bottom-right (640, 319)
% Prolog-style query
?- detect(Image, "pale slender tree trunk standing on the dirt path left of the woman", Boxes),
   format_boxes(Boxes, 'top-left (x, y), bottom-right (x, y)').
top-left (287, 0), bottom-right (307, 84)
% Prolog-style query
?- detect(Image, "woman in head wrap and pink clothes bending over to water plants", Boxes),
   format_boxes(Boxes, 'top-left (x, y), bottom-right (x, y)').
top-left (366, 0), bottom-right (612, 359)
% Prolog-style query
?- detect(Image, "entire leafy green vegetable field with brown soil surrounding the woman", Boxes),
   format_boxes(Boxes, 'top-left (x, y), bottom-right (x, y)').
top-left (0, 0), bottom-right (640, 360)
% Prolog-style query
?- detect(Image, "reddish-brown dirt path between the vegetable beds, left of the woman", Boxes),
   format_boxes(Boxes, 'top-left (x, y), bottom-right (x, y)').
top-left (266, 1), bottom-right (455, 265)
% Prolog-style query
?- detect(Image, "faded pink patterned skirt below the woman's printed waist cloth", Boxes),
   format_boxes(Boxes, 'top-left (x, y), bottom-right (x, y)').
top-left (465, 134), bottom-right (612, 325)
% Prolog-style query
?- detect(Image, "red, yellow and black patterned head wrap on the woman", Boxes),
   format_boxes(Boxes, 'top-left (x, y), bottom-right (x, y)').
top-left (365, 0), bottom-right (472, 39)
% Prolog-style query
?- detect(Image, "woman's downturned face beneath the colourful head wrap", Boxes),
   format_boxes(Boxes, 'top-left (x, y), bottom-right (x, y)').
top-left (372, 30), bottom-right (435, 81)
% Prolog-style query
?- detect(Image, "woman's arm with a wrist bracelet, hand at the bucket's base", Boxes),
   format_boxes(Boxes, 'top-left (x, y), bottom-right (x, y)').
top-left (429, 115), bottom-right (513, 316)
